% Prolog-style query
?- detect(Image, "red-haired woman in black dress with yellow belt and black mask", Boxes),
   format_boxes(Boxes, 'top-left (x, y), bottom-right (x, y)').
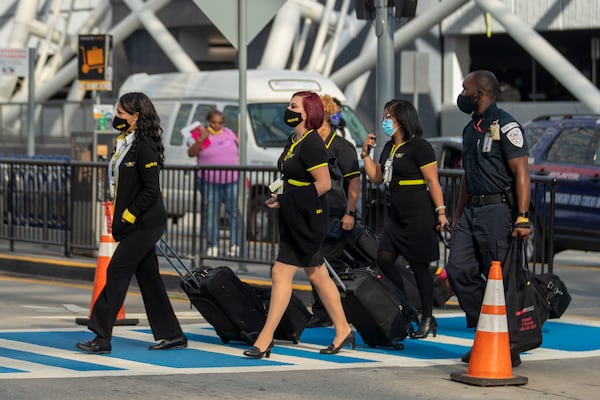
top-left (244, 92), bottom-right (355, 358)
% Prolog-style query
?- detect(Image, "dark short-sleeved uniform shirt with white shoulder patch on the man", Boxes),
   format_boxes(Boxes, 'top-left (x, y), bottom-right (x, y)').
top-left (463, 103), bottom-right (529, 195)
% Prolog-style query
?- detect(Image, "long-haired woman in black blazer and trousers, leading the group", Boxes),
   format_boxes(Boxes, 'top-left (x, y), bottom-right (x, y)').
top-left (77, 93), bottom-right (187, 354)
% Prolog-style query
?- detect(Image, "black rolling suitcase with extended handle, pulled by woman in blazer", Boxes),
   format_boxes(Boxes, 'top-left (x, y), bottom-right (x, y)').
top-left (156, 238), bottom-right (266, 345)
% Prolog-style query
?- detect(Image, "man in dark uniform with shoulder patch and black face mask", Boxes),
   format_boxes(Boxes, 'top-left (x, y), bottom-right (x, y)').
top-left (446, 71), bottom-right (531, 366)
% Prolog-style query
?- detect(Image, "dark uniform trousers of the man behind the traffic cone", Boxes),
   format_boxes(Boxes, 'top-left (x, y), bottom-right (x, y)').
top-left (446, 203), bottom-right (513, 328)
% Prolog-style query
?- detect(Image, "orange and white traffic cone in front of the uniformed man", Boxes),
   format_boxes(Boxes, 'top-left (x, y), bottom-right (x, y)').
top-left (450, 261), bottom-right (528, 386)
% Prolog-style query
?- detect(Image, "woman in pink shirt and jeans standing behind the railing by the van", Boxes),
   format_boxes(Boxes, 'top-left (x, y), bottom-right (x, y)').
top-left (188, 109), bottom-right (240, 257)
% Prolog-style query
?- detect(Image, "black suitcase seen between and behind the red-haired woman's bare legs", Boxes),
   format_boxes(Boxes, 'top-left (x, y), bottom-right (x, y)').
top-left (252, 286), bottom-right (312, 344)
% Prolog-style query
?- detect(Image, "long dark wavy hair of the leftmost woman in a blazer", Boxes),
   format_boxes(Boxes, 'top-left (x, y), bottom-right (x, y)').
top-left (119, 92), bottom-right (165, 167)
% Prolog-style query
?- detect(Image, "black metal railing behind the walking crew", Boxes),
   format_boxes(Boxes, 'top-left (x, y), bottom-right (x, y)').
top-left (0, 159), bottom-right (556, 272)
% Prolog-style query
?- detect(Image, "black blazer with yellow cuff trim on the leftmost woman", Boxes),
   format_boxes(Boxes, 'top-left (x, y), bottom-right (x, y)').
top-left (112, 137), bottom-right (167, 242)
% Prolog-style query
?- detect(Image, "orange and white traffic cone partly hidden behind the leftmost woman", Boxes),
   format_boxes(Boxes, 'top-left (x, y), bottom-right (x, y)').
top-left (75, 201), bottom-right (139, 325)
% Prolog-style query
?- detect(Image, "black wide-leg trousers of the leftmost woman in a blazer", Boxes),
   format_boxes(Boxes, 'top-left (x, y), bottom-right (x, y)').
top-left (88, 227), bottom-right (183, 340)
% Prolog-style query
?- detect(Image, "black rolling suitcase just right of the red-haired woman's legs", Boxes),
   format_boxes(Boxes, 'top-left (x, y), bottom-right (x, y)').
top-left (326, 262), bottom-right (417, 350)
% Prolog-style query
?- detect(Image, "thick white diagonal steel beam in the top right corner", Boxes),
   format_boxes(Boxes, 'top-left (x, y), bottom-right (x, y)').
top-left (475, 0), bottom-right (600, 113)
